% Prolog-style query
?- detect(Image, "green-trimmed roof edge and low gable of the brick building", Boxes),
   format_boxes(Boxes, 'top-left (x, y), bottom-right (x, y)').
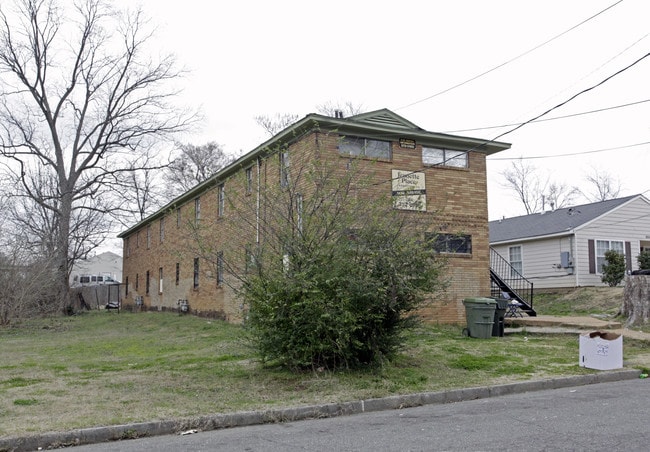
top-left (118, 108), bottom-right (510, 238)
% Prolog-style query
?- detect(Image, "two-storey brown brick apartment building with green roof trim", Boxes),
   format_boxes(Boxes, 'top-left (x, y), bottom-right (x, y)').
top-left (119, 109), bottom-right (510, 323)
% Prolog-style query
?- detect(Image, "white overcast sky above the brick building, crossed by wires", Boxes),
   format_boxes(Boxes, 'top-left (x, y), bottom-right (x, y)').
top-left (129, 0), bottom-right (650, 219)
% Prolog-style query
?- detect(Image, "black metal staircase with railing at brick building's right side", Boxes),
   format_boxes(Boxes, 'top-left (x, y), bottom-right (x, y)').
top-left (490, 247), bottom-right (537, 317)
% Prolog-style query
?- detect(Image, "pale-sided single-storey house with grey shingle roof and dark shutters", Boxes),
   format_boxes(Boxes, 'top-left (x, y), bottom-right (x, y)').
top-left (490, 195), bottom-right (650, 290)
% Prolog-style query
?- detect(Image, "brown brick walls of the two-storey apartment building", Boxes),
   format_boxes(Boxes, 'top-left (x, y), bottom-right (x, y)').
top-left (123, 132), bottom-right (490, 323)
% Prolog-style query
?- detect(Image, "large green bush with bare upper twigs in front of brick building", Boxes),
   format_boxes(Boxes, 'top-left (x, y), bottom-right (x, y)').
top-left (239, 157), bottom-right (444, 369)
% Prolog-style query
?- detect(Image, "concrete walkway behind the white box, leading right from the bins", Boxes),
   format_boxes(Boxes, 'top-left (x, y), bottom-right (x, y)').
top-left (505, 315), bottom-right (650, 342)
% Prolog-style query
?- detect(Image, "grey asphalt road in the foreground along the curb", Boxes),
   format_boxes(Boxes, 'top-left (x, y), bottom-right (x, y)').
top-left (73, 379), bottom-right (650, 452)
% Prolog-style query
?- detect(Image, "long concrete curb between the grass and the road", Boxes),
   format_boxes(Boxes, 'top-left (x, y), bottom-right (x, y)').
top-left (0, 369), bottom-right (641, 452)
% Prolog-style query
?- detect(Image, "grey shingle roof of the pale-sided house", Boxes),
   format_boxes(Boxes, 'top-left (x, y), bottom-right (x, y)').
top-left (489, 195), bottom-right (642, 244)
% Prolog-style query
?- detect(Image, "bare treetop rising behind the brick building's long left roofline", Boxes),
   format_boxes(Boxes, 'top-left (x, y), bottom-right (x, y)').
top-left (165, 141), bottom-right (234, 199)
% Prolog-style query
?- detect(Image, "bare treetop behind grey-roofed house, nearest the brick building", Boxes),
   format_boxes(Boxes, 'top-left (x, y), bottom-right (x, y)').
top-left (501, 159), bottom-right (580, 215)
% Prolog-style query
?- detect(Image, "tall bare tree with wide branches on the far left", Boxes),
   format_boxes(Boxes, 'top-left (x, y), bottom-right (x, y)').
top-left (0, 0), bottom-right (193, 306)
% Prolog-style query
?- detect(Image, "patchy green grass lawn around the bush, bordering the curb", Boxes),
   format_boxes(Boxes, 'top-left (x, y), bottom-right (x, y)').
top-left (0, 311), bottom-right (650, 437)
